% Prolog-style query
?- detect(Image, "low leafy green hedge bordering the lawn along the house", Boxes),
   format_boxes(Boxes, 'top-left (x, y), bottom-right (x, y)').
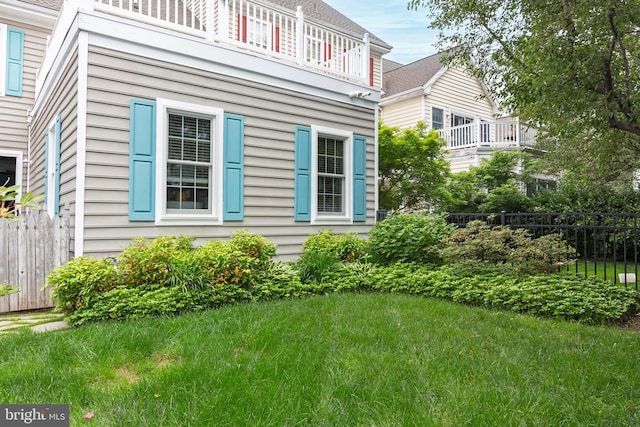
top-left (48, 227), bottom-right (638, 325)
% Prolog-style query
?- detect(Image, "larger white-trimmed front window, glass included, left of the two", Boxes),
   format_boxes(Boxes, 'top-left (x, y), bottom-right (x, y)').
top-left (155, 99), bottom-right (224, 224)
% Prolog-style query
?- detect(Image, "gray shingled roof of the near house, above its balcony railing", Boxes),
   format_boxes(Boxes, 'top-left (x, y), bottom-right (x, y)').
top-left (20, 0), bottom-right (391, 50)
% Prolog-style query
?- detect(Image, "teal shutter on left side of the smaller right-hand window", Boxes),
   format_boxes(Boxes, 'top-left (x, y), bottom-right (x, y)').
top-left (293, 126), bottom-right (311, 221)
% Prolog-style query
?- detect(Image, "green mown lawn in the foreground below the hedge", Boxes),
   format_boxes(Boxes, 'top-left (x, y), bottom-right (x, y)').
top-left (0, 294), bottom-right (640, 426)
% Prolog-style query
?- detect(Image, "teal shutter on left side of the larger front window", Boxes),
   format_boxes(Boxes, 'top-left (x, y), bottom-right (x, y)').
top-left (129, 99), bottom-right (156, 221)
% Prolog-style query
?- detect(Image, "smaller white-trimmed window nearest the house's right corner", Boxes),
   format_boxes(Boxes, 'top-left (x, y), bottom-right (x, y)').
top-left (311, 126), bottom-right (353, 223)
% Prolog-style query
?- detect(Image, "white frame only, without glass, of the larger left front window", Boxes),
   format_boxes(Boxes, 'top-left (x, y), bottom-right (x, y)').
top-left (155, 99), bottom-right (224, 225)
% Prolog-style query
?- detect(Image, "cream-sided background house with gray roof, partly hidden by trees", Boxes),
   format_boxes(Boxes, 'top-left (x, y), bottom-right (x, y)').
top-left (380, 54), bottom-right (541, 178)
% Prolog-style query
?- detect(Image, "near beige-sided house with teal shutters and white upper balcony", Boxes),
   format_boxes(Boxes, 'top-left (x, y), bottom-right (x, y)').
top-left (0, 0), bottom-right (391, 258)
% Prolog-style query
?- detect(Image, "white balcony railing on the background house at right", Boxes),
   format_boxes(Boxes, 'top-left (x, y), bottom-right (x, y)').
top-left (438, 119), bottom-right (537, 150)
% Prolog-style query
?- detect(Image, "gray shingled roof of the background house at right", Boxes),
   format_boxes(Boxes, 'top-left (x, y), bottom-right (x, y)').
top-left (382, 53), bottom-right (444, 98)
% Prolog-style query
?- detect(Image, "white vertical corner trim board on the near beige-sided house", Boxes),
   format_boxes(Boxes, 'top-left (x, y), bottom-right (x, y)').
top-left (73, 33), bottom-right (89, 257)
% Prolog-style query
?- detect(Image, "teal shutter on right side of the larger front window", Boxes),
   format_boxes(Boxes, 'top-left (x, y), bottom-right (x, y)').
top-left (222, 114), bottom-right (244, 221)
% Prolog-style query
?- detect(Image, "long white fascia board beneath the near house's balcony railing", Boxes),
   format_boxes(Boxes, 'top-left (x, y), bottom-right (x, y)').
top-left (78, 12), bottom-right (380, 109)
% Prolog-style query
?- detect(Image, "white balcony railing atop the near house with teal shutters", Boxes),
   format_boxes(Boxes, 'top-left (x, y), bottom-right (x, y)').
top-left (36, 0), bottom-right (370, 92)
